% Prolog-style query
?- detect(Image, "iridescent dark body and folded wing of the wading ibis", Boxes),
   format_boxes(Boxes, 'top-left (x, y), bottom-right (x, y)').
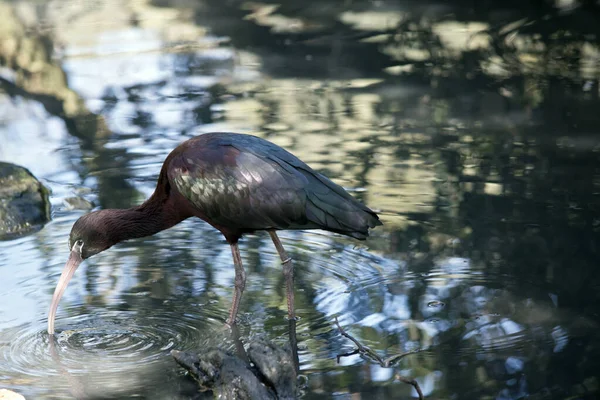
top-left (161, 133), bottom-right (381, 240)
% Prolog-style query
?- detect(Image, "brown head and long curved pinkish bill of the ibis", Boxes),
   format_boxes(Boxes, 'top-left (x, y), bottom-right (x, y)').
top-left (48, 210), bottom-right (118, 334)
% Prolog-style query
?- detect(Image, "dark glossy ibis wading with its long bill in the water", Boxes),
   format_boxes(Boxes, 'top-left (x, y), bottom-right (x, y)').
top-left (48, 132), bottom-right (382, 335)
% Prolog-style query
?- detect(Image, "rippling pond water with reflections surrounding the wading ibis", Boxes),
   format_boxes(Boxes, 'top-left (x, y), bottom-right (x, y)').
top-left (0, 0), bottom-right (600, 399)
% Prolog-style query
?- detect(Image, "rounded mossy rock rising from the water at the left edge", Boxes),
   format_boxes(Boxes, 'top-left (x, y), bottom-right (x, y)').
top-left (0, 162), bottom-right (50, 240)
